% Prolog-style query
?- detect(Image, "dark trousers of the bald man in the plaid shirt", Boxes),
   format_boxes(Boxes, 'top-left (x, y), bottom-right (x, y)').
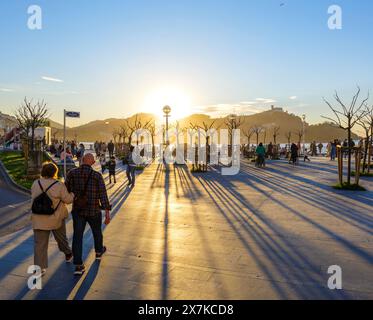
top-left (72, 211), bottom-right (103, 265)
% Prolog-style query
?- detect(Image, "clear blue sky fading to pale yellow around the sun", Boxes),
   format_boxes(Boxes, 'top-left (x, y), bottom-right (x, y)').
top-left (0, 0), bottom-right (373, 126)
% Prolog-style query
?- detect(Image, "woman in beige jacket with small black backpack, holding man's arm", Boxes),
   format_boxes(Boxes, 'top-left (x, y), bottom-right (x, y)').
top-left (31, 163), bottom-right (74, 275)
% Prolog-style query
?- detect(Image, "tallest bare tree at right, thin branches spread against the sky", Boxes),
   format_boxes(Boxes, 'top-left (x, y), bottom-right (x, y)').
top-left (323, 87), bottom-right (369, 184)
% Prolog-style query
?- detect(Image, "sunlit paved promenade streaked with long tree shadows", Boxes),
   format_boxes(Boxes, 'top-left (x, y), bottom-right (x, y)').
top-left (0, 159), bottom-right (373, 299)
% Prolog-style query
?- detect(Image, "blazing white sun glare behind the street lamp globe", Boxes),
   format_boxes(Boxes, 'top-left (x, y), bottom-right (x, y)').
top-left (144, 88), bottom-right (191, 120)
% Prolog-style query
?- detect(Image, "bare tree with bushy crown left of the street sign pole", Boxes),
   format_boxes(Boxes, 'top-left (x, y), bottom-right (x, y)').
top-left (15, 98), bottom-right (48, 151)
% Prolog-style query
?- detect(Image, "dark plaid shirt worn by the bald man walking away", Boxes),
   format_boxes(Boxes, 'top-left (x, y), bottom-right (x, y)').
top-left (65, 164), bottom-right (111, 217)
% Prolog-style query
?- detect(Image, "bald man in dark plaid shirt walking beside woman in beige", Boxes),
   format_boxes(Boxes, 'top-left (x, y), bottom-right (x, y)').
top-left (66, 153), bottom-right (111, 275)
